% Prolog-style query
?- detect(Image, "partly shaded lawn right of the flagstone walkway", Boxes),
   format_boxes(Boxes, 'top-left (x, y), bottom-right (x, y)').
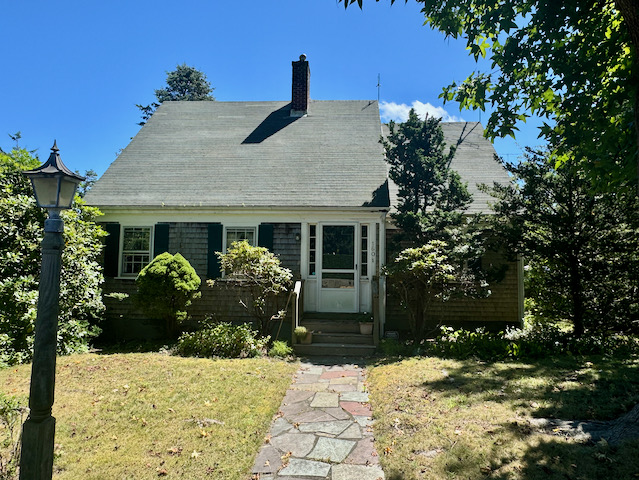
top-left (368, 357), bottom-right (639, 480)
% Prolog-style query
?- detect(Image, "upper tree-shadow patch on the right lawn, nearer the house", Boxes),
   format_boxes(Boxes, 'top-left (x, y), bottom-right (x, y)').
top-left (422, 357), bottom-right (639, 420)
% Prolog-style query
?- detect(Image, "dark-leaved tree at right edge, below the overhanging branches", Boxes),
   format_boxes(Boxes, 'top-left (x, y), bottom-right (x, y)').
top-left (484, 151), bottom-right (639, 336)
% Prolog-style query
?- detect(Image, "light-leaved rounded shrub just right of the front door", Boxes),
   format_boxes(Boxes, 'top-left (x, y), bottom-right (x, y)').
top-left (384, 240), bottom-right (484, 339)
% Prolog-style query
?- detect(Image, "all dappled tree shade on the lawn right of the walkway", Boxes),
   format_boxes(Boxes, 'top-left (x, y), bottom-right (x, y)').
top-left (377, 357), bottom-right (639, 480)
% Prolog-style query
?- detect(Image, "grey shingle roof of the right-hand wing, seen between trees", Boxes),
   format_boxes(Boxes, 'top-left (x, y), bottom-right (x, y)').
top-left (383, 122), bottom-right (510, 213)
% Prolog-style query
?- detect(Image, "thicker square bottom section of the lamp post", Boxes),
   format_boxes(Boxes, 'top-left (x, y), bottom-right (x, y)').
top-left (20, 417), bottom-right (55, 480)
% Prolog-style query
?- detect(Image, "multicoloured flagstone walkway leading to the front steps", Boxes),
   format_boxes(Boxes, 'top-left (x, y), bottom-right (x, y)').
top-left (253, 359), bottom-right (385, 480)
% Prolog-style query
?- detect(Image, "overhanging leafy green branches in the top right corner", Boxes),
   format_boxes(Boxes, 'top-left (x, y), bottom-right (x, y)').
top-left (340, 0), bottom-right (639, 190)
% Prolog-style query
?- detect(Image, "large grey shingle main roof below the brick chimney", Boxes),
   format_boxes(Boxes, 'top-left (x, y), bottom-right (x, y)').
top-left (86, 100), bottom-right (389, 208)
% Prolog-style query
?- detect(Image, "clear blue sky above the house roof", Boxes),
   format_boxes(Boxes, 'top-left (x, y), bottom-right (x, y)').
top-left (0, 0), bottom-right (540, 174)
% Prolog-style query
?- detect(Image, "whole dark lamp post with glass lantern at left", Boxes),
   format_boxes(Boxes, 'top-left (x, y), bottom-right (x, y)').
top-left (20, 142), bottom-right (84, 480)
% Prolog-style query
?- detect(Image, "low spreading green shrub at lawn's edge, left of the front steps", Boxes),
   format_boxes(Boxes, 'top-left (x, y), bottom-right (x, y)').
top-left (176, 322), bottom-right (270, 358)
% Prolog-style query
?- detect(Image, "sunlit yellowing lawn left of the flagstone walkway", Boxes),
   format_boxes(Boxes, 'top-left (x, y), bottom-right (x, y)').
top-left (0, 353), bottom-right (297, 480)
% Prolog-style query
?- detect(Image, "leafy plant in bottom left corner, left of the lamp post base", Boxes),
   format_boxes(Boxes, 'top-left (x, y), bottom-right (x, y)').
top-left (0, 392), bottom-right (27, 480)
